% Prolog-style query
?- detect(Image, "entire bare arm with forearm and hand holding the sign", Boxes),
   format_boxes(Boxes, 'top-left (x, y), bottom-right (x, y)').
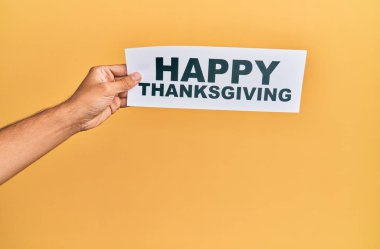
top-left (0, 65), bottom-right (141, 184)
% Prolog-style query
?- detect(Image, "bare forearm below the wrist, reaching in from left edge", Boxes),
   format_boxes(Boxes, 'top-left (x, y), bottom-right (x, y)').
top-left (0, 101), bottom-right (79, 184)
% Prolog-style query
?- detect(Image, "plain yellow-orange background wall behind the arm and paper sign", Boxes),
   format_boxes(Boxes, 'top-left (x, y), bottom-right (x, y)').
top-left (0, 0), bottom-right (380, 249)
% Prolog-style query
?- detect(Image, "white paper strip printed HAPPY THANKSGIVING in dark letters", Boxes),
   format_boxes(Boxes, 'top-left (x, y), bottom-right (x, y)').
top-left (125, 46), bottom-right (306, 112)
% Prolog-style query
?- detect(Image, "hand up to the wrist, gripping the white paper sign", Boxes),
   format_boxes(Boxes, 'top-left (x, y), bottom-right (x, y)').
top-left (62, 65), bottom-right (141, 131)
